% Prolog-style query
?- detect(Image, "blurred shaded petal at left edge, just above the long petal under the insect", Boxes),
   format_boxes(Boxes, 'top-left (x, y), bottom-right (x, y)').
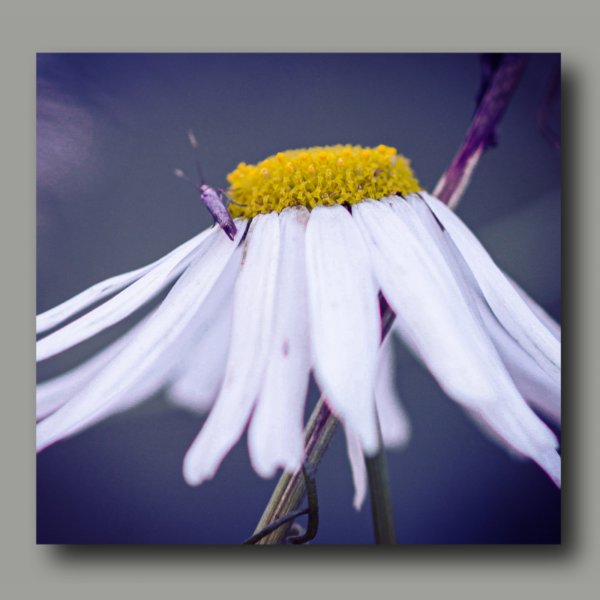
top-left (36, 308), bottom-right (155, 421)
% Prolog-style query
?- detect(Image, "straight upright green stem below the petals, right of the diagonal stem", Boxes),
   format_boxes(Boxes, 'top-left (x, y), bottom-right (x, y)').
top-left (365, 420), bottom-right (396, 544)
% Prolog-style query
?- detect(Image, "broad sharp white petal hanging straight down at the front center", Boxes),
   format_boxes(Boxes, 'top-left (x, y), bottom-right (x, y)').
top-left (306, 205), bottom-right (381, 455)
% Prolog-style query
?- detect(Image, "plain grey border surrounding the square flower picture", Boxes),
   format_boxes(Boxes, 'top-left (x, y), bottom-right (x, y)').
top-left (0, 0), bottom-right (600, 598)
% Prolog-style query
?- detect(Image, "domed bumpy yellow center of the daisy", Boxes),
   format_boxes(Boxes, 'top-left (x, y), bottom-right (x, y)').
top-left (227, 145), bottom-right (421, 218)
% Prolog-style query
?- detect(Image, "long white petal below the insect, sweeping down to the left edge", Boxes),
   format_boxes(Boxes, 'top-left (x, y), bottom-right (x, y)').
top-left (37, 227), bottom-right (244, 450)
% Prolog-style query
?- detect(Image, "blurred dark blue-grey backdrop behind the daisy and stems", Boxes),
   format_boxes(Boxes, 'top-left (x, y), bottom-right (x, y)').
top-left (37, 54), bottom-right (561, 544)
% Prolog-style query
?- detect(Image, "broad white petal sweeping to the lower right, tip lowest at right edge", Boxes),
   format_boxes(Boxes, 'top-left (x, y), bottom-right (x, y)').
top-left (353, 201), bottom-right (560, 485)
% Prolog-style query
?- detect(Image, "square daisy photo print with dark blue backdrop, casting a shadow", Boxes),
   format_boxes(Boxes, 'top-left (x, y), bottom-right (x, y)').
top-left (36, 53), bottom-right (561, 545)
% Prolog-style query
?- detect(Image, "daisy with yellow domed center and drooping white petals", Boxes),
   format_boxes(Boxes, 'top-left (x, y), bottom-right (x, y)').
top-left (37, 145), bottom-right (561, 507)
